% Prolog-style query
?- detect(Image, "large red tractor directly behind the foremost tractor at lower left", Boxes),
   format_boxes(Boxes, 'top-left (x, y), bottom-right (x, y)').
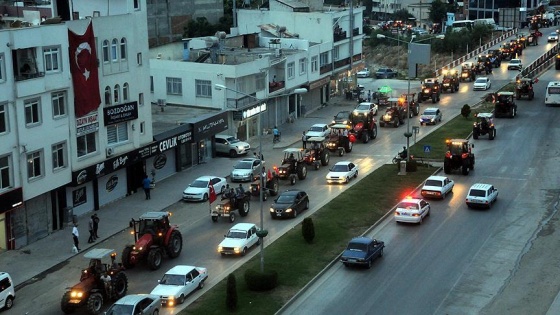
top-left (122, 211), bottom-right (183, 270)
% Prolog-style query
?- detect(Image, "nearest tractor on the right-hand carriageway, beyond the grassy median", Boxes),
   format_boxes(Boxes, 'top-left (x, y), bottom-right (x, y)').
top-left (443, 139), bottom-right (475, 175)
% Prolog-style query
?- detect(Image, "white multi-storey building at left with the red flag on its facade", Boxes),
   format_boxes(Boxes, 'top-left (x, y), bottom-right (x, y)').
top-left (0, 0), bottom-right (155, 250)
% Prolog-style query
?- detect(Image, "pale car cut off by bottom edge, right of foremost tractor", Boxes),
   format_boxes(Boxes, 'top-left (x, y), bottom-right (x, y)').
top-left (104, 294), bottom-right (161, 315)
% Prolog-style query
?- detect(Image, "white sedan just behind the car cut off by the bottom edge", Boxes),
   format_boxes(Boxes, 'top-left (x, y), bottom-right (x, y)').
top-left (150, 265), bottom-right (208, 308)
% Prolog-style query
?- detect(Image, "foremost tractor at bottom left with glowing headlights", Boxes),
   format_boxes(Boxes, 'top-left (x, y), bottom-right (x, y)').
top-left (60, 248), bottom-right (128, 315)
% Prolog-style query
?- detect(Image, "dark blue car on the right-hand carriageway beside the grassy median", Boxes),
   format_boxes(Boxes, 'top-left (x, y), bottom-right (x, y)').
top-left (340, 236), bottom-right (385, 269)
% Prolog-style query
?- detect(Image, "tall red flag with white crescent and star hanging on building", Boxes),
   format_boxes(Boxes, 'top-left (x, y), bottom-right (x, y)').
top-left (68, 23), bottom-right (101, 117)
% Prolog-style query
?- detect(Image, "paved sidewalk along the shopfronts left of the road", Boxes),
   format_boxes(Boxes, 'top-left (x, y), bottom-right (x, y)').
top-left (0, 97), bottom-right (356, 289)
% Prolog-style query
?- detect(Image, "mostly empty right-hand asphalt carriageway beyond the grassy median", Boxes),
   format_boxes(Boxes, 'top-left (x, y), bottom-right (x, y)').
top-left (283, 47), bottom-right (560, 314)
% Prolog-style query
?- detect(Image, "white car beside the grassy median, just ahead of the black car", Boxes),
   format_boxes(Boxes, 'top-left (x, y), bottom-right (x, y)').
top-left (218, 223), bottom-right (260, 256)
